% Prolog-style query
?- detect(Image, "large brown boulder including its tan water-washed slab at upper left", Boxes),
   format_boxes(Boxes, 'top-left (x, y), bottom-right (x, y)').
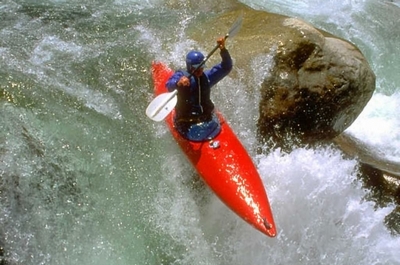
top-left (194, 6), bottom-right (375, 144)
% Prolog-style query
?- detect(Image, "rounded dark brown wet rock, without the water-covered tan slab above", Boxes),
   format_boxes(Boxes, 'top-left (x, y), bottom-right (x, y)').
top-left (258, 32), bottom-right (375, 146)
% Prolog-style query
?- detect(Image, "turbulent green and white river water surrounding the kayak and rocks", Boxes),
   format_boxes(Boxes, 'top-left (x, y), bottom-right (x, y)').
top-left (0, 0), bottom-right (400, 265)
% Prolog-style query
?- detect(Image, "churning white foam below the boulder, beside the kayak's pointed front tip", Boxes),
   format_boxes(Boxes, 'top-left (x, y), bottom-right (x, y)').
top-left (217, 148), bottom-right (400, 265)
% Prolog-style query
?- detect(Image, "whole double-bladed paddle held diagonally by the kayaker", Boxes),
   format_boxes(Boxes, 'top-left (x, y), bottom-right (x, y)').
top-left (146, 15), bottom-right (243, 121)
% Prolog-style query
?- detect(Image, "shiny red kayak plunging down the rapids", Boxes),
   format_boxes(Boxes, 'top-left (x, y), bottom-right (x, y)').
top-left (152, 62), bottom-right (276, 237)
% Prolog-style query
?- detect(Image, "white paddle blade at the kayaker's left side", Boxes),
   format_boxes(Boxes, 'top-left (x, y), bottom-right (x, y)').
top-left (146, 92), bottom-right (178, 121)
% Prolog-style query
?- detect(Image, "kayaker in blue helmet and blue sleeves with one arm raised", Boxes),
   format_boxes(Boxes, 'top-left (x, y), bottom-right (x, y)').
top-left (166, 38), bottom-right (232, 141)
